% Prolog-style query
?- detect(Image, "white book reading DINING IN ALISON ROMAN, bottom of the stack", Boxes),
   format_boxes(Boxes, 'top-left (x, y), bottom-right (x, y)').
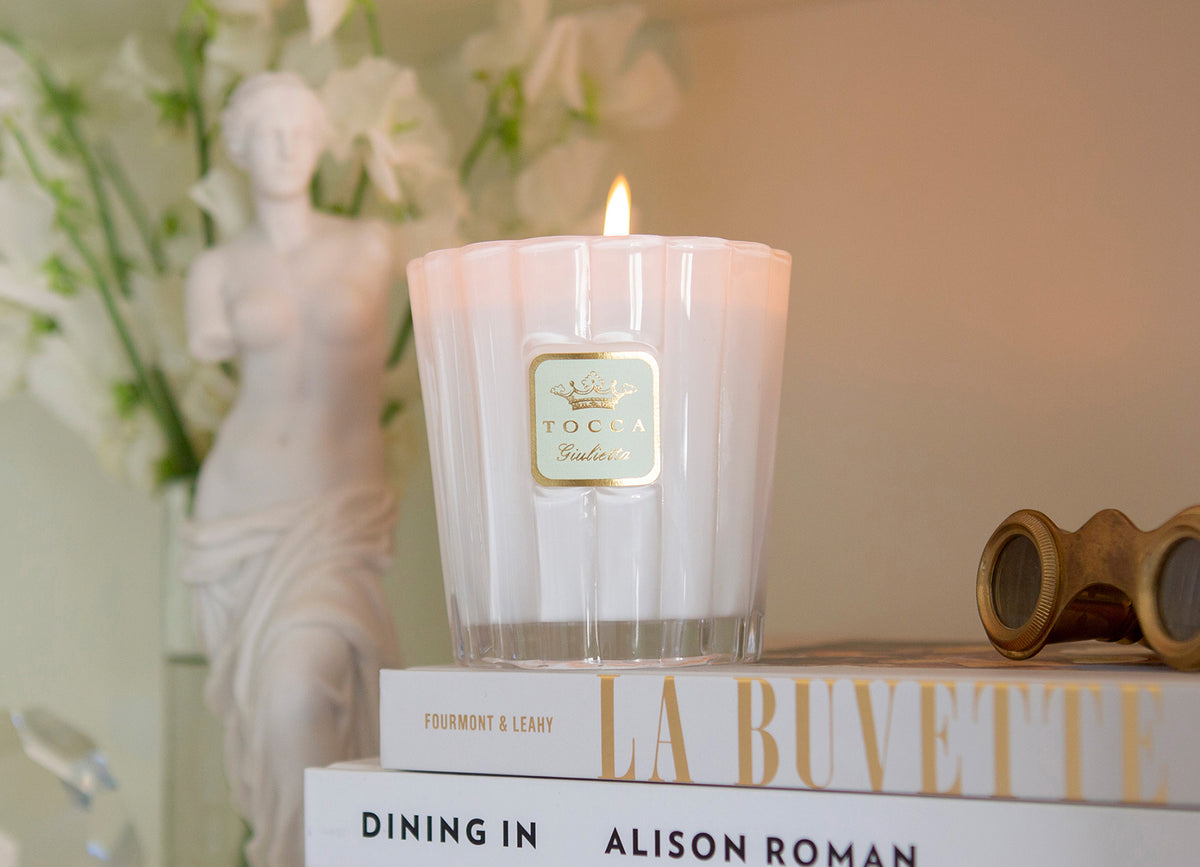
top-left (305, 760), bottom-right (1200, 867)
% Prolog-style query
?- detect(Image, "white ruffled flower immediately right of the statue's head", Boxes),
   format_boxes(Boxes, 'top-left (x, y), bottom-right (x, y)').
top-left (320, 58), bottom-right (448, 202)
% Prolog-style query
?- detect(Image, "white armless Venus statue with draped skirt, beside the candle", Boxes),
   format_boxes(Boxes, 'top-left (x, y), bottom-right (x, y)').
top-left (182, 73), bottom-right (397, 867)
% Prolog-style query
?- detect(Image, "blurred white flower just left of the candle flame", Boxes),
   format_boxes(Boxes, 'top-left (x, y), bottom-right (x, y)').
top-left (516, 136), bottom-right (608, 234)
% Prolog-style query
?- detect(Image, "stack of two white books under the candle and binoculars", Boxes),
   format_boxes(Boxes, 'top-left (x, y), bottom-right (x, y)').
top-left (305, 645), bottom-right (1200, 867)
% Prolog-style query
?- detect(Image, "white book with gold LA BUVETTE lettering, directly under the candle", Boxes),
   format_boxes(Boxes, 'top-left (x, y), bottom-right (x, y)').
top-left (380, 645), bottom-right (1200, 807)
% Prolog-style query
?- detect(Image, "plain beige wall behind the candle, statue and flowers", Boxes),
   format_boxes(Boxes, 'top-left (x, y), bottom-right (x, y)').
top-left (0, 0), bottom-right (1200, 851)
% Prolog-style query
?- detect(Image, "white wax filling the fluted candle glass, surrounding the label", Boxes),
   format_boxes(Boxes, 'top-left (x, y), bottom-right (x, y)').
top-left (409, 235), bottom-right (790, 648)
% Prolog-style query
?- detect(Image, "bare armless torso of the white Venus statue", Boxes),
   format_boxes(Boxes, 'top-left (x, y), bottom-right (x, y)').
top-left (189, 217), bottom-right (390, 518)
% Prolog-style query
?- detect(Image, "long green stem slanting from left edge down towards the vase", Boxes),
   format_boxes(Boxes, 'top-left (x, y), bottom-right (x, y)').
top-left (4, 118), bottom-right (199, 474)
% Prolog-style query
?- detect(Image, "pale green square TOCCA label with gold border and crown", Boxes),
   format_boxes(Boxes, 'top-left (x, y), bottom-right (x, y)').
top-left (529, 352), bottom-right (660, 486)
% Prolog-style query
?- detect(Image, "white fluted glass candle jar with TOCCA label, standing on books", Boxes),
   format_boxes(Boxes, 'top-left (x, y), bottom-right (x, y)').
top-left (408, 235), bottom-right (791, 668)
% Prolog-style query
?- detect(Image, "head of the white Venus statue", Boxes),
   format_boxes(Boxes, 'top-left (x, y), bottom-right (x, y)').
top-left (221, 72), bottom-right (329, 197)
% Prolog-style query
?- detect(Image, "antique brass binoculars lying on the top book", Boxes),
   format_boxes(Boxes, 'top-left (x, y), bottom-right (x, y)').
top-left (976, 506), bottom-right (1200, 670)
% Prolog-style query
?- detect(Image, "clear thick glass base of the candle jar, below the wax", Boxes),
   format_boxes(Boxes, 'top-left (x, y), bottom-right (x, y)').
top-left (455, 614), bottom-right (762, 669)
